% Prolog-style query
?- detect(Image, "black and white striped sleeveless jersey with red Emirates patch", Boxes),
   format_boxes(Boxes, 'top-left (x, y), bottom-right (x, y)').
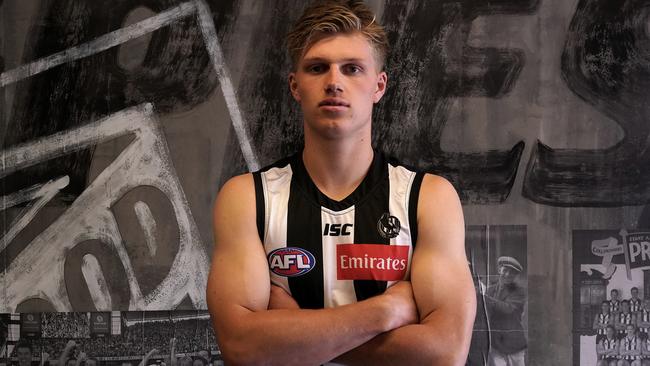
top-left (253, 151), bottom-right (424, 309)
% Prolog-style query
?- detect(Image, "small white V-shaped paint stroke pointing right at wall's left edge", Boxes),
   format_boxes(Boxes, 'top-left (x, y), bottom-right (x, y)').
top-left (0, 175), bottom-right (70, 252)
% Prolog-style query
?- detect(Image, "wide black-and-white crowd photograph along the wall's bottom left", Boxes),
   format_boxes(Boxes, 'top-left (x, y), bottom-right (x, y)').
top-left (5, 310), bottom-right (223, 366)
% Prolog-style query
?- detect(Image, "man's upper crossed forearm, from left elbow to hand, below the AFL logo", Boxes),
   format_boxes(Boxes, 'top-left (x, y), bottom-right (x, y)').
top-left (218, 297), bottom-right (415, 365)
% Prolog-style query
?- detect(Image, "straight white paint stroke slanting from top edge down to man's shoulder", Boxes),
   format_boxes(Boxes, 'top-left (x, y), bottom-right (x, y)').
top-left (194, 0), bottom-right (259, 171)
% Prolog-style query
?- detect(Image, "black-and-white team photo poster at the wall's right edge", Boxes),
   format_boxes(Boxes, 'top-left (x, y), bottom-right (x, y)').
top-left (573, 228), bottom-right (650, 366)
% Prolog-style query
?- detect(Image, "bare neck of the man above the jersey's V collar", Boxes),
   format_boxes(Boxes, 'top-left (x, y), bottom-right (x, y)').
top-left (302, 138), bottom-right (374, 201)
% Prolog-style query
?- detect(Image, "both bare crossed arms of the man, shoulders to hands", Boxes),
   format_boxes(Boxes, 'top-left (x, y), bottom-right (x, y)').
top-left (207, 174), bottom-right (476, 365)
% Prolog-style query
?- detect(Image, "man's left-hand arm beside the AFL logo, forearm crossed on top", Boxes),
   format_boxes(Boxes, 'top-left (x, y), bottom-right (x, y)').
top-left (207, 174), bottom-right (417, 365)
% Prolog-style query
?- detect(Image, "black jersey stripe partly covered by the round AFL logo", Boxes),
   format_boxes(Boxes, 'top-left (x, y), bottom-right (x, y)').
top-left (287, 179), bottom-right (325, 309)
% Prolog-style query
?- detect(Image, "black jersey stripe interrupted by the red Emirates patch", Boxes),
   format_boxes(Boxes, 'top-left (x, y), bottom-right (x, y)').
top-left (354, 176), bottom-right (390, 301)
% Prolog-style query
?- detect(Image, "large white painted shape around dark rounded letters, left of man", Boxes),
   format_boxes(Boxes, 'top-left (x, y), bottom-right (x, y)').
top-left (0, 103), bottom-right (210, 313)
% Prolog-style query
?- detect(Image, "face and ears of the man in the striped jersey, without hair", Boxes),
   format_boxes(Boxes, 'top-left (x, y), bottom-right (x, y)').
top-left (289, 33), bottom-right (387, 139)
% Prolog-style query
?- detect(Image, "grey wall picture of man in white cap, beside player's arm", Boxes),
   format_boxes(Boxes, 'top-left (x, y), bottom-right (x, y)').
top-left (465, 225), bottom-right (528, 366)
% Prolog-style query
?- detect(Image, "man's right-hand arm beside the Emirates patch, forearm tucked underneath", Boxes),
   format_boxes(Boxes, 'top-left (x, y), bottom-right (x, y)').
top-left (335, 174), bottom-right (476, 365)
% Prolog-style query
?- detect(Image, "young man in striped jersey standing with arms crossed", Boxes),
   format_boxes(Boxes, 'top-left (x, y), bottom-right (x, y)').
top-left (207, 1), bottom-right (476, 365)
